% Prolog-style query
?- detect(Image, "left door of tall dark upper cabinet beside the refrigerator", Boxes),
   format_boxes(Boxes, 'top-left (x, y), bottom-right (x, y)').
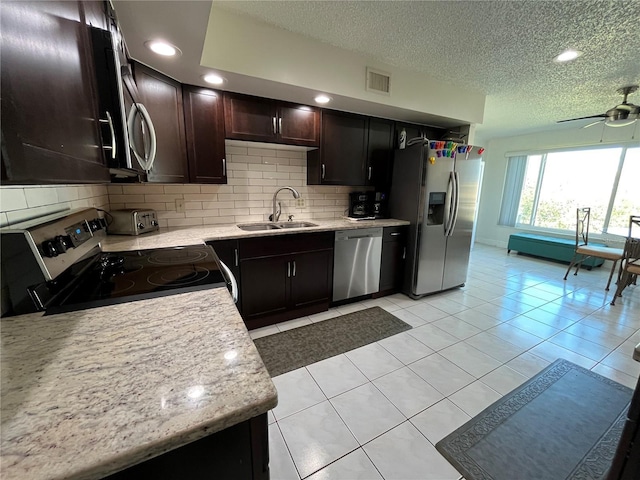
top-left (307, 110), bottom-right (368, 185)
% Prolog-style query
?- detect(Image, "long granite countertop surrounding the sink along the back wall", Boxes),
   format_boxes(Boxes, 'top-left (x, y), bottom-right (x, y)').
top-left (101, 218), bottom-right (409, 252)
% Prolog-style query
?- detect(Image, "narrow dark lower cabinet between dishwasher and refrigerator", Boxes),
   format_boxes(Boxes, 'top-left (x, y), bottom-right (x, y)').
top-left (374, 226), bottom-right (407, 297)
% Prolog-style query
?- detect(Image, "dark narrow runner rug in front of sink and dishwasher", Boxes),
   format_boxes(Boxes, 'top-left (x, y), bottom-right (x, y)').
top-left (254, 307), bottom-right (411, 377)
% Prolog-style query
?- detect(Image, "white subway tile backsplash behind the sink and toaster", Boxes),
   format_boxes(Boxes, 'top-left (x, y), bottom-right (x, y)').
top-left (95, 142), bottom-right (356, 226)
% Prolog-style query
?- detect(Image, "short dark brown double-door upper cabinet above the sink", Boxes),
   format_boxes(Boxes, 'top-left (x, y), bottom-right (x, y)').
top-left (224, 93), bottom-right (320, 147)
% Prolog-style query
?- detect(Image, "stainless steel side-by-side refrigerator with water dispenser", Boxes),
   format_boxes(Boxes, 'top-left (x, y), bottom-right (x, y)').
top-left (389, 139), bottom-right (484, 298)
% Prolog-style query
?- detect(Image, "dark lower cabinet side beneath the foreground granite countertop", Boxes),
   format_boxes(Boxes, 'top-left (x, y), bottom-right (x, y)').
top-left (105, 413), bottom-right (269, 480)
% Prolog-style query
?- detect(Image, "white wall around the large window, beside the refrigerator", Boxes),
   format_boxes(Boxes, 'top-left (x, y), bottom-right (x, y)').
top-left (476, 122), bottom-right (640, 248)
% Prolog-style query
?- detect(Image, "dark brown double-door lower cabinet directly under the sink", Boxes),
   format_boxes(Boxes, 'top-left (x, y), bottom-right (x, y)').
top-left (240, 232), bottom-right (333, 329)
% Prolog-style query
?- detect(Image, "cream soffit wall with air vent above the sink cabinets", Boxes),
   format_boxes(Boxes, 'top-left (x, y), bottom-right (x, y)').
top-left (201, 7), bottom-right (485, 123)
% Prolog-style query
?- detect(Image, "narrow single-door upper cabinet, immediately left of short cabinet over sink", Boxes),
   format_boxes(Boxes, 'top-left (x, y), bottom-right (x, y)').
top-left (182, 85), bottom-right (227, 183)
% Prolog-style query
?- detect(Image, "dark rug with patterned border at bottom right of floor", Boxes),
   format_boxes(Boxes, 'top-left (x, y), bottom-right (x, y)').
top-left (436, 360), bottom-right (633, 480)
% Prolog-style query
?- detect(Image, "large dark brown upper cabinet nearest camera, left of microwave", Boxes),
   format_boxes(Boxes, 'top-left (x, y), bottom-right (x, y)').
top-left (0, 1), bottom-right (109, 184)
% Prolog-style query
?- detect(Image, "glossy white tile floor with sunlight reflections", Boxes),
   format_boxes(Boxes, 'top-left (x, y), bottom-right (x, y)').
top-left (251, 245), bottom-right (640, 480)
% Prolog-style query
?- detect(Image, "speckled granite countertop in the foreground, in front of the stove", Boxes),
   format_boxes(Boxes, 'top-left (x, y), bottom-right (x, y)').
top-left (0, 288), bottom-right (277, 480)
